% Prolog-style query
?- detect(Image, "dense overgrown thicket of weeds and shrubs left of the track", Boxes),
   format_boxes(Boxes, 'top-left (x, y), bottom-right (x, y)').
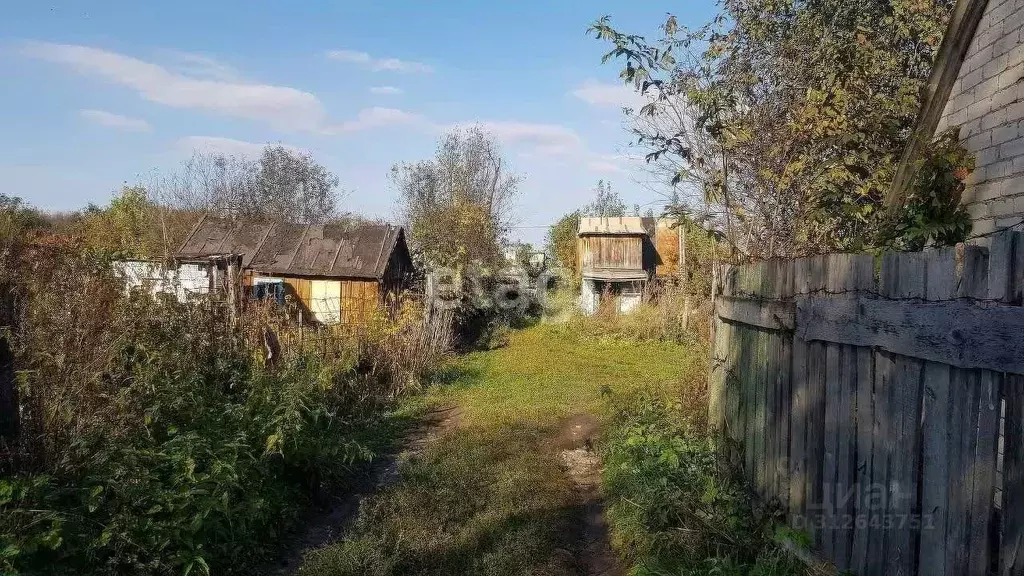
top-left (0, 247), bottom-right (448, 574)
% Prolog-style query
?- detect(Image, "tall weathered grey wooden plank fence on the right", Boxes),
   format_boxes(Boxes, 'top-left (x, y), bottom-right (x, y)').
top-left (710, 232), bottom-right (1024, 576)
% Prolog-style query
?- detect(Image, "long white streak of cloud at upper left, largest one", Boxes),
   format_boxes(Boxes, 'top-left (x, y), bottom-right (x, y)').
top-left (24, 42), bottom-right (327, 130)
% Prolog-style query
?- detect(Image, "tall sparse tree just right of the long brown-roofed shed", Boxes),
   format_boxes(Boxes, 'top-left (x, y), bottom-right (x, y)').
top-left (391, 126), bottom-right (520, 270)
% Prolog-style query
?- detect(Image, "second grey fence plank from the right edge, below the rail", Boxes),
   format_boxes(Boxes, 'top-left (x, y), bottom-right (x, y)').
top-left (967, 370), bottom-right (1002, 576)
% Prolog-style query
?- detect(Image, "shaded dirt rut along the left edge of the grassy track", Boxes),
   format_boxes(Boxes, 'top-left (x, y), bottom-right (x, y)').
top-left (272, 406), bottom-right (462, 575)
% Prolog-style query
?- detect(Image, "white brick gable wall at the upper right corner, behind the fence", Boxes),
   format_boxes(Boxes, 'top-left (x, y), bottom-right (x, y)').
top-left (936, 0), bottom-right (1024, 234)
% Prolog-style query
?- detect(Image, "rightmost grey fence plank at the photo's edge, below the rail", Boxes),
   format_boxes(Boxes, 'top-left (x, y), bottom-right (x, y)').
top-left (999, 376), bottom-right (1024, 576)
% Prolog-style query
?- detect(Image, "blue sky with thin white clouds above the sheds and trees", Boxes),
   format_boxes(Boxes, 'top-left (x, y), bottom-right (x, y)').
top-left (0, 0), bottom-right (714, 241)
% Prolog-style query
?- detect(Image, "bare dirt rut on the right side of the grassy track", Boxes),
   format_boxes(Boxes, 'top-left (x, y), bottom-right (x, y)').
top-left (555, 414), bottom-right (625, 576)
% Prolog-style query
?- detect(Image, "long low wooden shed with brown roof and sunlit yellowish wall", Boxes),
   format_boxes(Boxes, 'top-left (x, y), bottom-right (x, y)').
top-left (177, 216), bottom-right (413, 324)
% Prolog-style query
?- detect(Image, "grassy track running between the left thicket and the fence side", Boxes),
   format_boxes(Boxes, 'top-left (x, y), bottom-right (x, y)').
top-left (299, 325), bottom-right (698, 576)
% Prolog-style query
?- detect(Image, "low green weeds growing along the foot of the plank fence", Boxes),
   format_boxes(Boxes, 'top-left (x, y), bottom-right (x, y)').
top-left (603, 395), bottom-right (803, 576)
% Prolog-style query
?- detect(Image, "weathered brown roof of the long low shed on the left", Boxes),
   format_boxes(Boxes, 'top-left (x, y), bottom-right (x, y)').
top-left (175, 216), bottom-right (404, 279)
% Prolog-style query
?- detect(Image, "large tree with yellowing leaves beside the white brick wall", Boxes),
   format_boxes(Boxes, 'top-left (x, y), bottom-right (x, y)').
top-left (590, 0), bottom-right (953, 256)
